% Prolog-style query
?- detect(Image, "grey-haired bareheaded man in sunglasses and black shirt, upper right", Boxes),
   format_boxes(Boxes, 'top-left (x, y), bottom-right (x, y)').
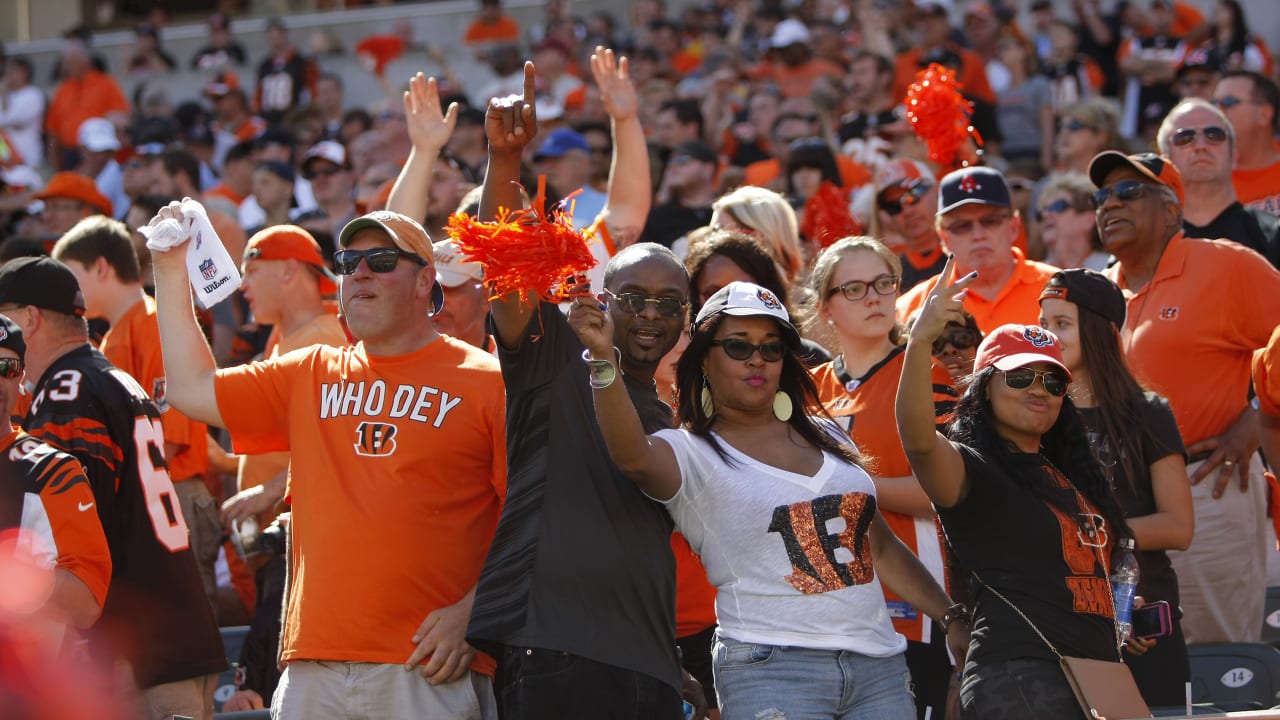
top-left (1156, 99), bottom-right (1280, 268)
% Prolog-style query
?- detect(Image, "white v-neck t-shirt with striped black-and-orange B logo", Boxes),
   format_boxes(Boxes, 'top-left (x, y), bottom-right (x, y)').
top-left (655, 429), bottom-right (906, 657)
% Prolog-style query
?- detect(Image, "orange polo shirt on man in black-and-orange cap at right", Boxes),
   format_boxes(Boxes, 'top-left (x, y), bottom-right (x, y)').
top-left (1106, 233), bottom-right (1280, 446)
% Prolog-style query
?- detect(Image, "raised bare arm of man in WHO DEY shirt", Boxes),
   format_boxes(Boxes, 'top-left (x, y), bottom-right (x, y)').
top-left (148, 201), bottom-right (223, 428)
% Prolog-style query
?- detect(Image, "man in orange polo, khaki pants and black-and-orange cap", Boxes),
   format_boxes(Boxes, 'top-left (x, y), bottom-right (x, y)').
top-left (1089, 148), bottom-right (1280, 643)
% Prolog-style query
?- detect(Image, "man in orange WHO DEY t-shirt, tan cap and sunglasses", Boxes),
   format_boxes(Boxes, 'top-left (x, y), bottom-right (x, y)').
top-left (152, 206), bottom-right (507, 720)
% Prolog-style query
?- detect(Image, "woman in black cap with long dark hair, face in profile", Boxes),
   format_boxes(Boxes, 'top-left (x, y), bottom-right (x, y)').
top-left (1039, 269), bottom-right (1196, 706)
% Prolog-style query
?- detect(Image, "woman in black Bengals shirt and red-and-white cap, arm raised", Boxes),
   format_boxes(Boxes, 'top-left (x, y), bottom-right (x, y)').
top-left (896, 261), bottom-right (1129, 720)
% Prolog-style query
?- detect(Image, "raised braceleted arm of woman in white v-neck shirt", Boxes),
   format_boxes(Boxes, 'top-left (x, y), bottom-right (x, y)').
top-left (568, 297), bottom-right (680, 500)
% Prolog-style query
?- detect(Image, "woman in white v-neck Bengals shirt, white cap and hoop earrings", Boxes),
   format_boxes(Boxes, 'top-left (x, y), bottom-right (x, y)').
top-left (568, 282), bottom-right (968, 720)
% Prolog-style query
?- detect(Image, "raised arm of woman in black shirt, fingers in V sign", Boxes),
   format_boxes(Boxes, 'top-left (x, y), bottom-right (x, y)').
top-left (896, 258), bottom-right (978, 507)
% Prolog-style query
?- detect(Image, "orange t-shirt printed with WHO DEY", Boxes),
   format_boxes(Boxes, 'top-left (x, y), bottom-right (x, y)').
top-left (214, 337), bottom-right (507, 675)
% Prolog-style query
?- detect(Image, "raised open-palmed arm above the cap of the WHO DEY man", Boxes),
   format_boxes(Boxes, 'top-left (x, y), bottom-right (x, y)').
top-left (387, 73), bottom-right (458, 223)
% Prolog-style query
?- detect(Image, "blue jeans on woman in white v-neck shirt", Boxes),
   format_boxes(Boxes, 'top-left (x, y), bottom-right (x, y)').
top-left (712, 635), bottom-right (915, 720)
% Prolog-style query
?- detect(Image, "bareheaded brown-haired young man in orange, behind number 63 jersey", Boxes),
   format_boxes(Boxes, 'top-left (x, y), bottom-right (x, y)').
top-left (52, 215), bottom-right (223, 615)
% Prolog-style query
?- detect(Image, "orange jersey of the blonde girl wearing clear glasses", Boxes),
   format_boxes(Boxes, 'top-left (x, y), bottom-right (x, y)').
top-left (812, 351), bottom-right (957, 642)
